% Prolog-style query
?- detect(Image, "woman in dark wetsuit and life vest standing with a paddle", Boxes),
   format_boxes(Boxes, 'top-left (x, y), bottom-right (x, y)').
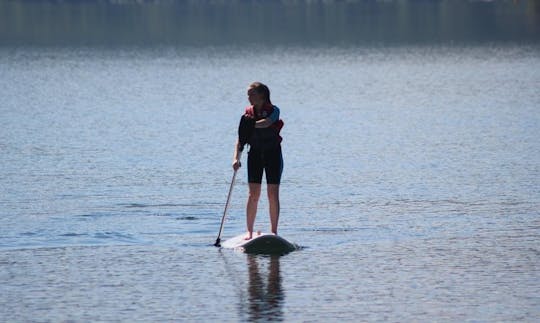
top-left (232, 82), bottom-right (283, 240)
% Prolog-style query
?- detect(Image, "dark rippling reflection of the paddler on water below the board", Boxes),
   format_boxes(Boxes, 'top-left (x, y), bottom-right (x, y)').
top-left (247, 255), bottom-right (285, 321)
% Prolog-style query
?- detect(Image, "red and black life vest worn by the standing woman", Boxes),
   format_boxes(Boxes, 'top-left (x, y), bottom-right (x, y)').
top-left (244, 104), bottom-right (284, 149)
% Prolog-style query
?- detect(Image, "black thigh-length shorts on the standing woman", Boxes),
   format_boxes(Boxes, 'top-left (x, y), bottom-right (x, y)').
top-left (248, 146), bottom-right (283, 184)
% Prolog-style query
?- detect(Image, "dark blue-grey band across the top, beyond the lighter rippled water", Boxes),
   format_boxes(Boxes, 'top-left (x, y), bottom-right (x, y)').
top-left (0, 0), bottom-right (540, 47)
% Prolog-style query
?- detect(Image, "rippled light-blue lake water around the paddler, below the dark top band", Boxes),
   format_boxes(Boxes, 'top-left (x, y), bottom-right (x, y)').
top-left (0, 1), bottom-right (540, 322)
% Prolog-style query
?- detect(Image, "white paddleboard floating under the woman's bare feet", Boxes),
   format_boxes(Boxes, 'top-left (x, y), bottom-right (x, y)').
top-left (221, 233), bottom-right (298, 254)
